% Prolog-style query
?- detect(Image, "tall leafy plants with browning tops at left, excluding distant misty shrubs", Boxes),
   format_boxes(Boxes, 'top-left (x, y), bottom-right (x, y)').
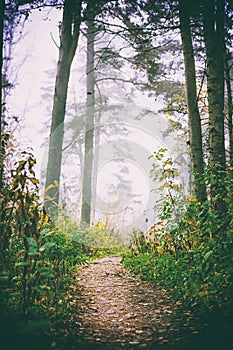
top-left (0, 152), bottom-right (84, 317)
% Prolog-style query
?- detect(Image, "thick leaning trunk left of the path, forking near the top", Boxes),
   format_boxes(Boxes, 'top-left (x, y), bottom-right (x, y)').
top-left (45, 0), bottom-right (82, 216)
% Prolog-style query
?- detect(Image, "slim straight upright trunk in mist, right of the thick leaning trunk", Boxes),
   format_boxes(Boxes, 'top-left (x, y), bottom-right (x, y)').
top-left (81, 9), bottom-right (95, 226)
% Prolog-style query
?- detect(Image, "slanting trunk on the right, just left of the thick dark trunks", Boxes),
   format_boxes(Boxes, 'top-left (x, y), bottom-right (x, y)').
top-left (179, 0), bottom-right (207, 203)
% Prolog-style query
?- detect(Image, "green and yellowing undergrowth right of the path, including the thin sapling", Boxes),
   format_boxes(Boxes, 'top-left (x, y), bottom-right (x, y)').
top-left (123, 156), bottom-right (233, 313)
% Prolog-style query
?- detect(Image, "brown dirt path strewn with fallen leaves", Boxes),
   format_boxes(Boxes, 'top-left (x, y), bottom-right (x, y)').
top-left (67, 256), bottom-right (196, 350)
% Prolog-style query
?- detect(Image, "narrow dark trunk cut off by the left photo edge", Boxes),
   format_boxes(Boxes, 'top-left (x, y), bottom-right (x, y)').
top-left (0, 0), bottom-right (5, 189)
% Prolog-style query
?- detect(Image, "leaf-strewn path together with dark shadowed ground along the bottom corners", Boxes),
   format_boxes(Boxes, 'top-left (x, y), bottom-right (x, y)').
top-left (0, 256), bottom-right (233, 350)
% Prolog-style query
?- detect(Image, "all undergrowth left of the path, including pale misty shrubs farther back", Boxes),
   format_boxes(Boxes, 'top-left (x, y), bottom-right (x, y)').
top-left (0, 152), bottom-right (125, 342)
